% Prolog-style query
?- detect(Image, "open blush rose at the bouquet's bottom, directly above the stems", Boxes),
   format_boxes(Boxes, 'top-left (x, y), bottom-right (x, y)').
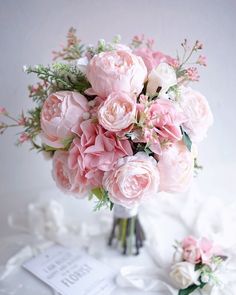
top-left (103, 152), bottom-right (159, 208)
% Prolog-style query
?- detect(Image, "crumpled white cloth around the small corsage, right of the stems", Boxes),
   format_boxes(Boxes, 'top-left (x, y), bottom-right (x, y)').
top-left (117, 188), bottom-right (236, 295)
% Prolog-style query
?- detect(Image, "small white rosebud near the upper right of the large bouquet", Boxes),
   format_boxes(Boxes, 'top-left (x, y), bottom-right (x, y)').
top-left (147, 63), bottom-right (177, 95)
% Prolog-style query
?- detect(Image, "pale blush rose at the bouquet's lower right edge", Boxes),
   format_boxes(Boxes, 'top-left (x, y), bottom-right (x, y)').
top-left (158, 141), bottom-right (195, 193)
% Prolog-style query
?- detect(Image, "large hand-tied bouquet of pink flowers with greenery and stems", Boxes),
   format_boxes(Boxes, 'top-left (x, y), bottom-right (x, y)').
top-left (0, 29), bottom-right (213, 253)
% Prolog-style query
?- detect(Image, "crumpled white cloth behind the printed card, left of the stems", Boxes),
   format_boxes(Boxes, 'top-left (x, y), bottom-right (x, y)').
top-left (0, 192), bottom-right (112, 281)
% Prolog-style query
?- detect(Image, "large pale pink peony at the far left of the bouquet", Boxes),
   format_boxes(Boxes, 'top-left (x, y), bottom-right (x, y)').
top-left (40, 91), bottom-right (89, 148)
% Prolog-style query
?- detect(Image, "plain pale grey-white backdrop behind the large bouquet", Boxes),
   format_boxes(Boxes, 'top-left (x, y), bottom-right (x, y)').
top-left (0, 0), bottom-right (236, 199)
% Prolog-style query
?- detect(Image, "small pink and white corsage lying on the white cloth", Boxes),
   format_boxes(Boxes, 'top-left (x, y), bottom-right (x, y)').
top-left (170, 236), bottom-right (228, 295)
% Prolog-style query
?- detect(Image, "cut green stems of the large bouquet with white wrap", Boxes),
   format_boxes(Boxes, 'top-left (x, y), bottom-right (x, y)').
top-left (108, 205), bottom-right (145, 255)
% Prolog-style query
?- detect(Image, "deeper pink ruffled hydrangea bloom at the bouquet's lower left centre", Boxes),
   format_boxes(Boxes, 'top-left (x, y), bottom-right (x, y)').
top-left (69, 119), bottom-right (133, 187)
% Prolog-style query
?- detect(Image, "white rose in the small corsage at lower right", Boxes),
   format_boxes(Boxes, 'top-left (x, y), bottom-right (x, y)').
top-left (170, 261), bottom-right (200, 289)
